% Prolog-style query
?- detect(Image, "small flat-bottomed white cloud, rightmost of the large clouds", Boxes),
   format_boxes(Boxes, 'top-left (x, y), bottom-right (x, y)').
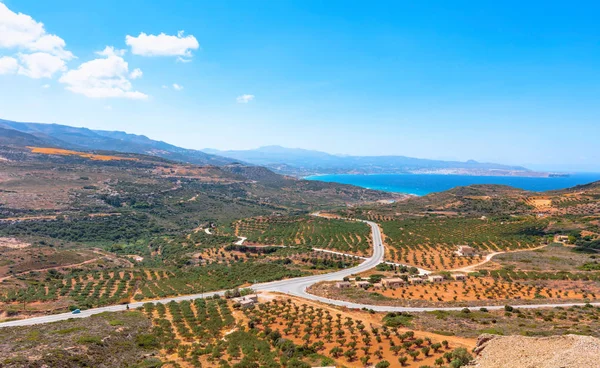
top-left (125, 31), bottom-right (200, 57)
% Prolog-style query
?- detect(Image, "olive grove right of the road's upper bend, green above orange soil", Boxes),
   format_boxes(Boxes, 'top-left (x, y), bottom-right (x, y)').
top-left (381, 217), bottom-right (548, 270)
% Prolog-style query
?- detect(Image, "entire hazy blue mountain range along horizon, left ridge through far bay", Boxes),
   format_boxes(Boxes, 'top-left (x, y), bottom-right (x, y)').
top-left (0, 119), bottom-right (548, 177)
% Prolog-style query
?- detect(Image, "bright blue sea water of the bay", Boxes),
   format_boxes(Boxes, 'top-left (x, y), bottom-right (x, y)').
top-left (305, 173), bottom-right (600, 196)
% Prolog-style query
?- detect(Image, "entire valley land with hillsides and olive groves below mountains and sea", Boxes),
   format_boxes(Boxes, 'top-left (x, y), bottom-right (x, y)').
top-left (0, 144), bottom-right (600, 368)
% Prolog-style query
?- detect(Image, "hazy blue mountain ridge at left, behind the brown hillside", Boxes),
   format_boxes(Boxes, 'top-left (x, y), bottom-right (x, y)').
top-left (0, 119), bottom-right (237, 166)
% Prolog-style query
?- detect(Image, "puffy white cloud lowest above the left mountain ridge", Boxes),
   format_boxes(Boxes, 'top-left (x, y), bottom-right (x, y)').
top-left (59, 55), bottom-right (148, 100)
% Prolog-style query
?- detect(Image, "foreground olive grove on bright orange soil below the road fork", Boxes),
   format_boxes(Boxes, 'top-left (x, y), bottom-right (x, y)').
top-left (245, 299), bottom-right (470, 367)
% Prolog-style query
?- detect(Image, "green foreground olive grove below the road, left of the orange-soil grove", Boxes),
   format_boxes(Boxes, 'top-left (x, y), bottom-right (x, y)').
top-left (142, 299), bottom-right (346, 368)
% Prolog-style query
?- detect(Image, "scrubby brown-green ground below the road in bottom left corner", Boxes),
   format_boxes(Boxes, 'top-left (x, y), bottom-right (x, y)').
top-left (0, 312), bottom-right (160, 368)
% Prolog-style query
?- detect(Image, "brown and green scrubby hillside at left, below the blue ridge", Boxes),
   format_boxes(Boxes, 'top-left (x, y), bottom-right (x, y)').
top-left (0, 145), bottom-right (390, 227)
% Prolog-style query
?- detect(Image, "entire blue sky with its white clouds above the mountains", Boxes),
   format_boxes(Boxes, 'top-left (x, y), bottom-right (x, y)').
top-left (0, 0), bottom-right (600, 171)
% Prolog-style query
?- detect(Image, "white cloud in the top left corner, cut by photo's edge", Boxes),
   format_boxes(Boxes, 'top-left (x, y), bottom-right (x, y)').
top-left (0, 2), bottom-right (75, 60)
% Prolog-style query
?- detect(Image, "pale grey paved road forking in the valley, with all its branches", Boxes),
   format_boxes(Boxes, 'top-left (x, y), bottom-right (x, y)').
top-left (0, 221), bottom-right (600, 327)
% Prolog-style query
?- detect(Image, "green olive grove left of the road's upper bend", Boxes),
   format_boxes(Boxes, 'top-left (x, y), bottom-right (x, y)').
top-left (234, 216), bottom-right (371, 255)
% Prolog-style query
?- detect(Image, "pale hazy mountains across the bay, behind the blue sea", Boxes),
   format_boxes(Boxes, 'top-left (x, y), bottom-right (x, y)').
top-left (203, 146), bottom-right (547, 176)
